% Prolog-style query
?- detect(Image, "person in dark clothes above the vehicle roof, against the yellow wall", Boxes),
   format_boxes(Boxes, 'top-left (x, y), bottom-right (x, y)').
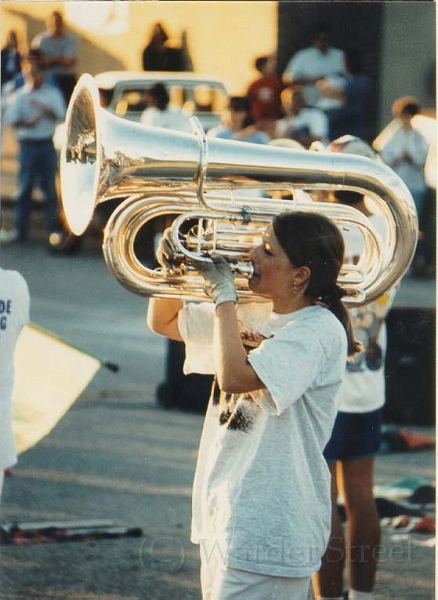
top-left (142, 23), bottom-right (184, 71)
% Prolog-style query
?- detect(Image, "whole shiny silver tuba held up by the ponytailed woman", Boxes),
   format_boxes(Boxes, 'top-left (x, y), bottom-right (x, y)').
top-left (60, 74), bottom-right (418, 305)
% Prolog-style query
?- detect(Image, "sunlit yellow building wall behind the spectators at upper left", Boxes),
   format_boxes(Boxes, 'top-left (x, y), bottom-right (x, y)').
top-left (1, 0), bottom-right (277, 93)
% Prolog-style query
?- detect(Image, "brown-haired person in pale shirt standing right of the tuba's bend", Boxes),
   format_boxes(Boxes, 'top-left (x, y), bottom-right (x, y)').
top-left (380, 96), bottom-right (429, 275)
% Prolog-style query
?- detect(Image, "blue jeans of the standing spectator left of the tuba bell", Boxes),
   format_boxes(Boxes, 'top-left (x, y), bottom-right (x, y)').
top-left (15, 139), bottom-right (59, 241)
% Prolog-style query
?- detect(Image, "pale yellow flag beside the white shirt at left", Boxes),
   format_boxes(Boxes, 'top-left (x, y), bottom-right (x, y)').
top-left (12, 324), bottom-right (102, 454)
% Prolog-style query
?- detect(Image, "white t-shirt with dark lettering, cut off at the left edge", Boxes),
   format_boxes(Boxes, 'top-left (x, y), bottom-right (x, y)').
top-left (0, 267), bottom-right (30, 470)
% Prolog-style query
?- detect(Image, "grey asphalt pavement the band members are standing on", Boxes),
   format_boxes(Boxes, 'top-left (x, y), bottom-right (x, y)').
top-left (0, 132), bottom-right (435, 600)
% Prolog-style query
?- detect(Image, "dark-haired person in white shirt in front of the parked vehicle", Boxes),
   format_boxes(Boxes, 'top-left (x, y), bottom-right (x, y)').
top-left (140, 83), bottom-right (192, 133)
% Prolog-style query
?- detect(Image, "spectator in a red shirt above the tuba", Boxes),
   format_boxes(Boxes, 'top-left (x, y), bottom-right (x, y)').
top-left (246, 56), bottom-right (284, 138)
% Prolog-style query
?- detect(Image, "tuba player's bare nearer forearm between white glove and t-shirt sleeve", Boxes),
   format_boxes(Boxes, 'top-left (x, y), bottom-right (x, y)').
top-left (214, 302), bottom-right (265, 394)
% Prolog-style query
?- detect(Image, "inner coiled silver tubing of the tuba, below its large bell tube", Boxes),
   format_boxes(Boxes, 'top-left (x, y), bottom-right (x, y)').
top-left (103, 194), bottom-right (383, 305)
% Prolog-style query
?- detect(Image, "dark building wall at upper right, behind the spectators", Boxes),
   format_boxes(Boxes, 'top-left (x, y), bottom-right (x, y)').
top-left (278, 0), bottom-right (436, 134)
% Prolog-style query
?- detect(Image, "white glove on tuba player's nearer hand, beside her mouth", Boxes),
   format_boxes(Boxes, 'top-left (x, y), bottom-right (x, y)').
top-left (195, 254), bottom-right (237, 306)
